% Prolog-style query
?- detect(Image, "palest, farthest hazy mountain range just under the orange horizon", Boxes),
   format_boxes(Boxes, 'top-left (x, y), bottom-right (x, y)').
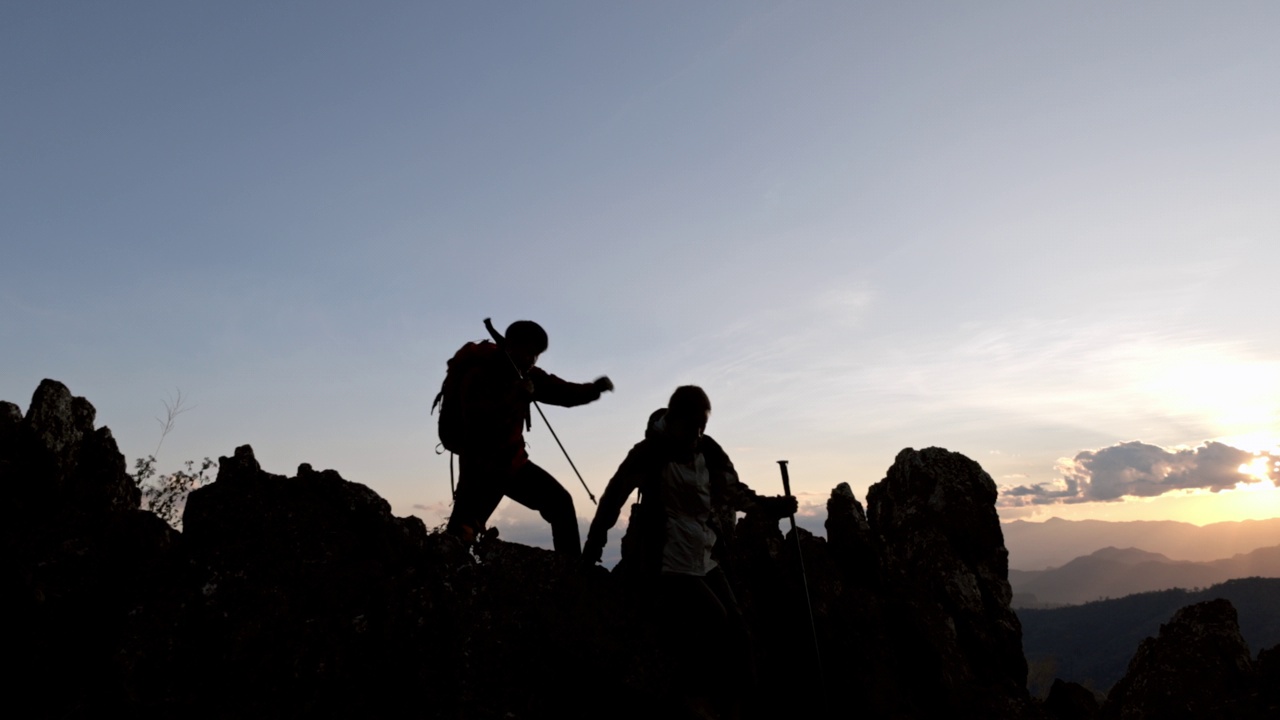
top-left (1001, 518), bottom-right (1280, 568)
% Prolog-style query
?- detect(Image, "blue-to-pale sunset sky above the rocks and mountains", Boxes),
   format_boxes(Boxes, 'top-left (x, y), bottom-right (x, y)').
top-left (0, 0), bottom-right (1280, 546)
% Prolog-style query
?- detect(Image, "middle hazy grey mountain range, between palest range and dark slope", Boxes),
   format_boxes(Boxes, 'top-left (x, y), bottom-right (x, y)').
top-left (1009, 544), bottom-right (1280, 607)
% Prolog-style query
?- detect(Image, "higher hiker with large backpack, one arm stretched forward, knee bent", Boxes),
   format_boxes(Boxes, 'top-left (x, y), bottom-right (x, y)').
top-left (435, 320), bottom-right (613, 559)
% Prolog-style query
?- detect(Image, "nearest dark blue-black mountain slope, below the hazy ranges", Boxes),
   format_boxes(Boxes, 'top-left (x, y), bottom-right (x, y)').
top-left (1018, 571), bottom-right (1280, 696)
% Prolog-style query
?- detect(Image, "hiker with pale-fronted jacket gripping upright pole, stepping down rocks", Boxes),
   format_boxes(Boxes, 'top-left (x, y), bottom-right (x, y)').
top-left (582, 386), bottom-right (796, 716)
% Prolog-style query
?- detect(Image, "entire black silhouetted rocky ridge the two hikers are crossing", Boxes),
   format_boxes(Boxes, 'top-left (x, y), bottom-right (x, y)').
top-left (0, 380), bottom-right (1276, 719)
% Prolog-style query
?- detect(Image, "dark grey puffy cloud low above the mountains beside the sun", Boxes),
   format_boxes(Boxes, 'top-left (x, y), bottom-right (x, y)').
top-left (1000, 441), bottom-right (1277, 507)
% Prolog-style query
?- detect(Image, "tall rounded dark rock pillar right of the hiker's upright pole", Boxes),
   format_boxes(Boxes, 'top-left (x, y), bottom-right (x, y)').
top-left (867, 447), bottom-right (1027, 716)
